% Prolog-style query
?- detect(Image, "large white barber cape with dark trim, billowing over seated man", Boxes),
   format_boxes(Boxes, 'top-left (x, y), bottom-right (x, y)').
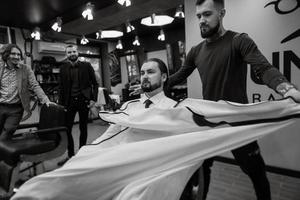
top-left (12, 99), bottom-right (300, 200)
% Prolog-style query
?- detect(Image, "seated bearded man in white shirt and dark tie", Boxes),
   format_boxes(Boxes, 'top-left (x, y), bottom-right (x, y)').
top-left (94, 58), bottom-right (177, 146)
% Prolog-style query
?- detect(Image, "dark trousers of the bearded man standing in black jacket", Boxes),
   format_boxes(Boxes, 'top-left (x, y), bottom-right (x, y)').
top-left (66, 96), bottom-right (89, 157)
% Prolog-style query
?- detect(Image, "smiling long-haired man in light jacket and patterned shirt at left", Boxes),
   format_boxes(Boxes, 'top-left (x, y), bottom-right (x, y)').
top-left (0, 44), bottom-right (52, 140)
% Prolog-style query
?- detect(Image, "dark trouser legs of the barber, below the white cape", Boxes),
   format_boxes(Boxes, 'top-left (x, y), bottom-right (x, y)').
top-left (202, 141), bottom-right (271, 200)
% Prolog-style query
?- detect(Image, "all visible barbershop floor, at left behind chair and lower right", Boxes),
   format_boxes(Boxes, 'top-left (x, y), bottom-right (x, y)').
top-left (8, 120), bottom-right (300, 200)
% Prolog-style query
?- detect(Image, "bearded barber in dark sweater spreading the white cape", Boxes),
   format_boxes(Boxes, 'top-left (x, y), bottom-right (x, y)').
top-left (169, 0), bottom-right (300, 200)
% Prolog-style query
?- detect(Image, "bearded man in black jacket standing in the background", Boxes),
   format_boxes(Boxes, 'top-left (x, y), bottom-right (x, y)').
top-left (58, 45), bottom-right (98, 165)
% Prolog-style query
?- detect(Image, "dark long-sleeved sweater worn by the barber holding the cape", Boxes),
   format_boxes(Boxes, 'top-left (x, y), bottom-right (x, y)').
top-left (168, 31), bottom-right (287, 103)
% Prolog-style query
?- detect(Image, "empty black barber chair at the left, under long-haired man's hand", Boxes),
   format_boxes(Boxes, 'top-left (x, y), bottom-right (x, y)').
top-left (0, 105), bottom-right (67, 194)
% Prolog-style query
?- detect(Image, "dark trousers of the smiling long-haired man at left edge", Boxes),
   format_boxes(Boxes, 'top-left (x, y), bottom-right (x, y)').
top-left (0, 103), bottom-right (24, 140)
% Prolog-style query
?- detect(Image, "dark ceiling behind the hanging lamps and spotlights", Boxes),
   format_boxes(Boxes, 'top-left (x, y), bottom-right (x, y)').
top-left (0, 0), bottom-right (184, 40)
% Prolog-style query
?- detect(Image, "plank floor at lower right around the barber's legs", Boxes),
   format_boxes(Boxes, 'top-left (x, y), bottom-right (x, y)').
top-left (207, 162), bottom-right (300, 200)
